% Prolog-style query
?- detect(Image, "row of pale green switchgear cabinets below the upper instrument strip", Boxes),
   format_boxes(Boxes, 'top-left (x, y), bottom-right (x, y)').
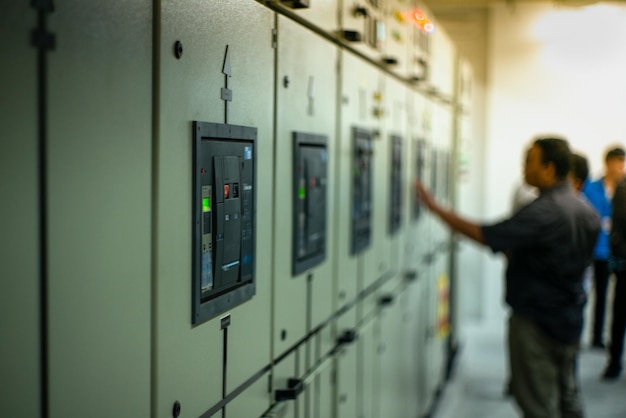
top-left (0, 0), bottom-right (468, 417)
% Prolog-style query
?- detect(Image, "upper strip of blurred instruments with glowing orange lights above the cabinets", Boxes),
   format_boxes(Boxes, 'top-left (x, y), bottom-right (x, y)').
top-left (266, 0), bottom-right (454, 97)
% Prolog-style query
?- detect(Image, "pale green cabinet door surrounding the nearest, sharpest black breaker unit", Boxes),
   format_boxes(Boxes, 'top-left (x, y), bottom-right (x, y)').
top-left (154, 0), bottom-right (275, 417)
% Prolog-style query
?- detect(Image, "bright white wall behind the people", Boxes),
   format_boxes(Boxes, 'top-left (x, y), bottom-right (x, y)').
top-left (482, 3), bottom-right (626, 321)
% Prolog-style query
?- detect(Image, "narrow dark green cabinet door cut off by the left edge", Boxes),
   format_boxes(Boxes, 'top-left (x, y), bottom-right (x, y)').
top-left (0, 1), bottom-right (42, 417)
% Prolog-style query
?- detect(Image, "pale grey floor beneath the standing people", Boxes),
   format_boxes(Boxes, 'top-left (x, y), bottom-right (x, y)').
top-left (432, 321), bottom-right (626, 418)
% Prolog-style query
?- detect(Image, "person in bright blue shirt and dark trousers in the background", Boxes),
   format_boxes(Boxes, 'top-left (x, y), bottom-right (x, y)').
top-left (583, 147), bottom-right (626, 348)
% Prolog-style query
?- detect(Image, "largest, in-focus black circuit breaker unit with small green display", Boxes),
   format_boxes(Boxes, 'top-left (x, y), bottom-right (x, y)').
top-left (192, 122), bottom-right (257, 325)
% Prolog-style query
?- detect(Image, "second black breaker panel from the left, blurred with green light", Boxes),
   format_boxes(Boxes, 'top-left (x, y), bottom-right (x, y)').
top-left (292, 132), bottom-right (328, 276)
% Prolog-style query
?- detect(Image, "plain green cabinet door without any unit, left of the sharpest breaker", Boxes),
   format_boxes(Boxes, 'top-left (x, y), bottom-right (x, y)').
top-left (46, 0), bottom-right (153, 417)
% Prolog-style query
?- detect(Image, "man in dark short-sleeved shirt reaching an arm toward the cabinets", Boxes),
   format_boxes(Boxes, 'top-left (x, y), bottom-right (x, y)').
top-left (415, 138), bottom-right (600, 418)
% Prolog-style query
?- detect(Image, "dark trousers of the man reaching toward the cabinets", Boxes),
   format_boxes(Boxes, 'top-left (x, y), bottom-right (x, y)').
top-left (509, 313), bottom-right (584, 418)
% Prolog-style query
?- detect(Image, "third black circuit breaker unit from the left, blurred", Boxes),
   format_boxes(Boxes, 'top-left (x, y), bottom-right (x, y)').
top-left (352, 127), bottom-right (373, 255)
